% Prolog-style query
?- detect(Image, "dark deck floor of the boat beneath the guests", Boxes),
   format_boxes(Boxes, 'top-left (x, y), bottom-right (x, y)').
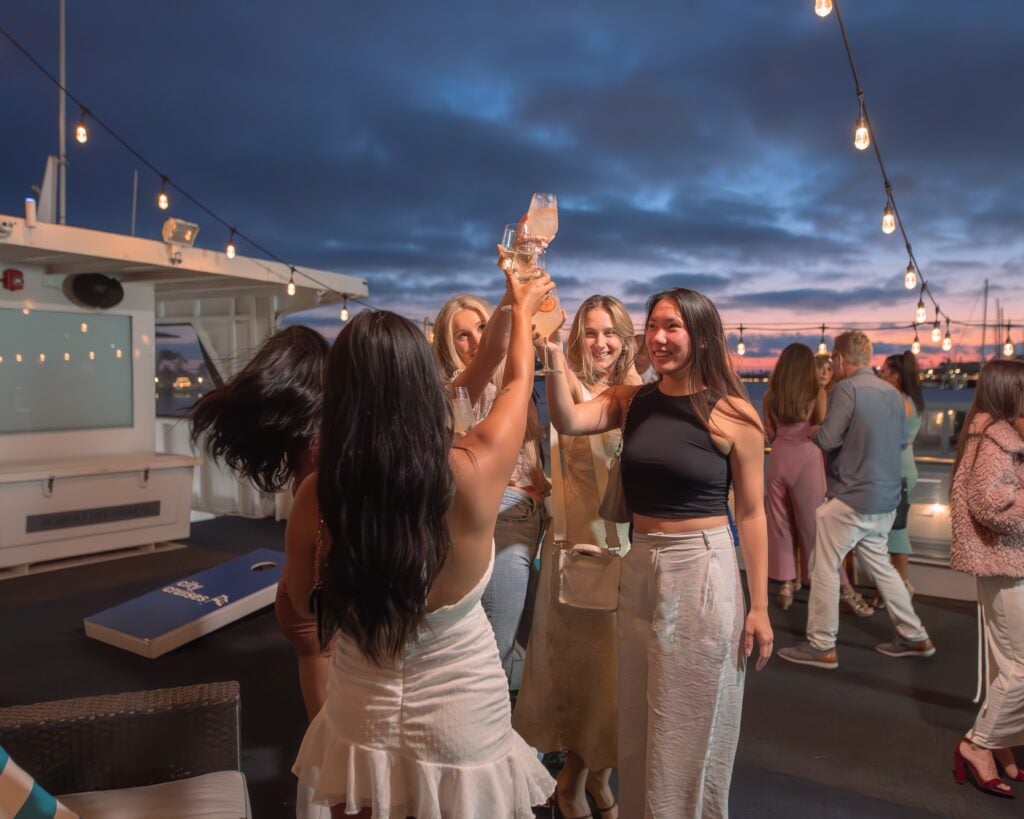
top-left (0, 518), bottom-right (1024, 819)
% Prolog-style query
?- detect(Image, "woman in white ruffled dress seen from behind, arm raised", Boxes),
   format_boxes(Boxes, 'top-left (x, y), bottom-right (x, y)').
top-left (287, 266), bottom-right (554, 819)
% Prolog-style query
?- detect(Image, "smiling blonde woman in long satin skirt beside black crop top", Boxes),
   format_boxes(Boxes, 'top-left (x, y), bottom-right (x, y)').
top-left (512, 296), bottom-right (640, 819)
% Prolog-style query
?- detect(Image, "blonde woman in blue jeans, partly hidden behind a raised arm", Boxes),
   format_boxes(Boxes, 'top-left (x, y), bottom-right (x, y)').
top-left (434, 295), bottom-right (548, 682)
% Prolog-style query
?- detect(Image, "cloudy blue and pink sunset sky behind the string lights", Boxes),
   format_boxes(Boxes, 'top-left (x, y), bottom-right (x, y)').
top-left (0, 0), bottom-right (1024, 369)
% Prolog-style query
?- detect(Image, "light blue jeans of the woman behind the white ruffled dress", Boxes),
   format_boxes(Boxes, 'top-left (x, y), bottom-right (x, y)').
top-left (480, 486), bottom-right (545, 681)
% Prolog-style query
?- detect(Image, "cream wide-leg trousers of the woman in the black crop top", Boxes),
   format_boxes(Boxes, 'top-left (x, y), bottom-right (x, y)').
top-left (618, 526), bottom-right (745, 819)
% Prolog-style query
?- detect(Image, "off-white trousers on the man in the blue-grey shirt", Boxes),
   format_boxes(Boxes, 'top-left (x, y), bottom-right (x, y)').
top-left (807, 498), bottom-right (928, 650)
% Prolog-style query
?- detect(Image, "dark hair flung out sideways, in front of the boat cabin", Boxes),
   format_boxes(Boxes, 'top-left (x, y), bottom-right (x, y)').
top-left (190, 326), bottom-right (329, 492)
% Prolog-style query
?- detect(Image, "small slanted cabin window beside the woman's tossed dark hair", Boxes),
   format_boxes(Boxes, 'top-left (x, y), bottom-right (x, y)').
top-left (156, 325), bottom-right (221, 418)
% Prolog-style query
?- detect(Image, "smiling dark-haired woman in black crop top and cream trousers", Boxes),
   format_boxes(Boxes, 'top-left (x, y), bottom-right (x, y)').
top-left (548, 288), bottom-right (772, 819)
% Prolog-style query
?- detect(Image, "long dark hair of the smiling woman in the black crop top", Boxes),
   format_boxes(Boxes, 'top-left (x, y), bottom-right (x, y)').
top-left (644, 288), bottom-right (760, 427)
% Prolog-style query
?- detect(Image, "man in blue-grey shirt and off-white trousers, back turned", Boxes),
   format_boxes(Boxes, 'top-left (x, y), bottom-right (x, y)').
top-left (779, 331), bottom-right (935, 669)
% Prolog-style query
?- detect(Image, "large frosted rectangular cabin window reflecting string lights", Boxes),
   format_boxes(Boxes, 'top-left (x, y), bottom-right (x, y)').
top-left (0, 307), bottom-right (133, 434)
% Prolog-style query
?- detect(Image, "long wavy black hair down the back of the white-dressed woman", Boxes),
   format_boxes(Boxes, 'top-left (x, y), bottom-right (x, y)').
top-left (316, 310), bottom-right (455, 664)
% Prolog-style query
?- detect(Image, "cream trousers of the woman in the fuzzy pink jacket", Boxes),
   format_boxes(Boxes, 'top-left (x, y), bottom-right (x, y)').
top-left (968, 577), bottom-right (1024, 748)
